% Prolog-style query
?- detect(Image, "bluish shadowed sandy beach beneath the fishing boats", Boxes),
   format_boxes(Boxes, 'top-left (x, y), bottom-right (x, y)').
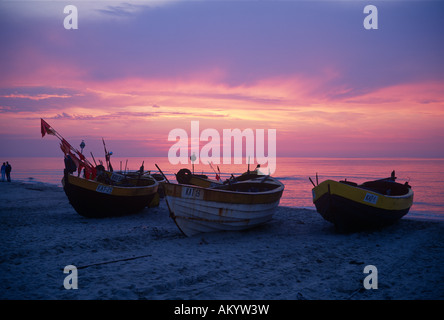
top-left (0, 181), bottom-right (444, 300)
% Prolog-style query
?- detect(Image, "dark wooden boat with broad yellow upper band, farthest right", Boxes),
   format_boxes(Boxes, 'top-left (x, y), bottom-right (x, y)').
top-left (310, 171), bottom-right (413, 232)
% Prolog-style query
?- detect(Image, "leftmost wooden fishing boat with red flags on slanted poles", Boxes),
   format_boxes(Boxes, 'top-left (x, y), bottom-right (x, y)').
top-left (41, 119), bottom-right (159, 218)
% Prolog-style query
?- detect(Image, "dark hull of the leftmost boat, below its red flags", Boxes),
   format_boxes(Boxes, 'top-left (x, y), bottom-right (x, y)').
top-left (62, 175), bottom-right (158, 218)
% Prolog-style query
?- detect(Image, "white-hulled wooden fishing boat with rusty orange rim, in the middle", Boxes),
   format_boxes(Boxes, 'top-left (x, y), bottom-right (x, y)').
top-left (165, 176), bottom-right (284, 236)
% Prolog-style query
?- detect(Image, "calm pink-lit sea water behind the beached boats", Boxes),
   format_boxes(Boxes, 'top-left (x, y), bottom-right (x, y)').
top-left (5, 157), bottom-right (444, 220)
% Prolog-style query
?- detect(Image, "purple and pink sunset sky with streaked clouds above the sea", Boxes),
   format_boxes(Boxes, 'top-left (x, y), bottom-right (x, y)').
top-left (0, 0), bottom-right (444, 158)
